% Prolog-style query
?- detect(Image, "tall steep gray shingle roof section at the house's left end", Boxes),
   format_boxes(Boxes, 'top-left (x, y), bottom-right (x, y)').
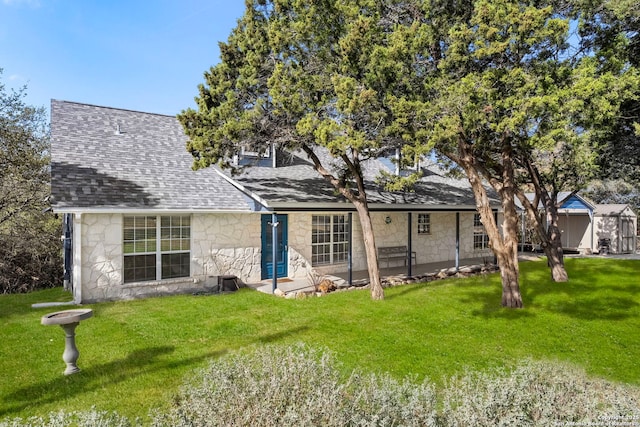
top-left (51, 100), bottom-right (251, 211)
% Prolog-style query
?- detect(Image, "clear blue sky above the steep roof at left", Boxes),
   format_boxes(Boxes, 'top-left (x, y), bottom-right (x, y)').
top-left (0, 0), bottom-right (244, 115)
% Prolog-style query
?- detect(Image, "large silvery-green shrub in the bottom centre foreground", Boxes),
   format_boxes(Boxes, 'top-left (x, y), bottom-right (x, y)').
top-left (154, 345), bottom-right (435, 426)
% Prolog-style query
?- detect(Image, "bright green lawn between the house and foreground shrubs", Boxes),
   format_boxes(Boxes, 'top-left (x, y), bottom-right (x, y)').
top-left (0, 259), bottom-right (640, 419)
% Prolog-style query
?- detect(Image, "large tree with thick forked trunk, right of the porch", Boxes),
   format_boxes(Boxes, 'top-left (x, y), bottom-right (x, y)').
top-left (389, 0), bottom-right (638, 300)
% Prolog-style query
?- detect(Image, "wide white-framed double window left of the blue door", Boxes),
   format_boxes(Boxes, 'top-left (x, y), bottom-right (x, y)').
top-left (123, 216), bottom-right (191, 283)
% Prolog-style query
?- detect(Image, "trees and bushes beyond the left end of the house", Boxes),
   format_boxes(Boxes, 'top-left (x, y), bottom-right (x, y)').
top-left (0, 70), bottom-right (62, 293)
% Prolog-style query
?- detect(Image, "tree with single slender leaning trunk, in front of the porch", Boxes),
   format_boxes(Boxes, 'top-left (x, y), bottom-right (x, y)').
top-left (178, 0), bottom-right (440, 299)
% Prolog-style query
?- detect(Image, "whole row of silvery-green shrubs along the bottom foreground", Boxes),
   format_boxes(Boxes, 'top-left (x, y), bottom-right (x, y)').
top-left (5, 344), bottom-right (640, 427)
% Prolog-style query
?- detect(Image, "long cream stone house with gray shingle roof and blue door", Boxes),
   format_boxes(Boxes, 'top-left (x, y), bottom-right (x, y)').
top-left (51, 100), bottom-right (499, 303)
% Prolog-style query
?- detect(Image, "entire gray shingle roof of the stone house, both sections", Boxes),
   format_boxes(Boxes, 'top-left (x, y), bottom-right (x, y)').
top-left (51, 100), bottom-right (498, 211)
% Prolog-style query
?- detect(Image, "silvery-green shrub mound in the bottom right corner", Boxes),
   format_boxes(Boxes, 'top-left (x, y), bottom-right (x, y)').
top-left (441, 361), bottom-right (640, 427)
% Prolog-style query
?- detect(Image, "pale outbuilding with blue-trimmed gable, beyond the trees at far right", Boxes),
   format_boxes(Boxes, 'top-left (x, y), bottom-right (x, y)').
top-left (527, 192), bottom-right (638, 254)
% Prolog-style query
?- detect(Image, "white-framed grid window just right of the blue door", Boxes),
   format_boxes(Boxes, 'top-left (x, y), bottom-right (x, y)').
top-left (311, 215), bottom-right (349, 265)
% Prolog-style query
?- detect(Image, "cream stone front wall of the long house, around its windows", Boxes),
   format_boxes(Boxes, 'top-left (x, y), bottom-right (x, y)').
top-left (74, 212), bottom-right (491, 302)
